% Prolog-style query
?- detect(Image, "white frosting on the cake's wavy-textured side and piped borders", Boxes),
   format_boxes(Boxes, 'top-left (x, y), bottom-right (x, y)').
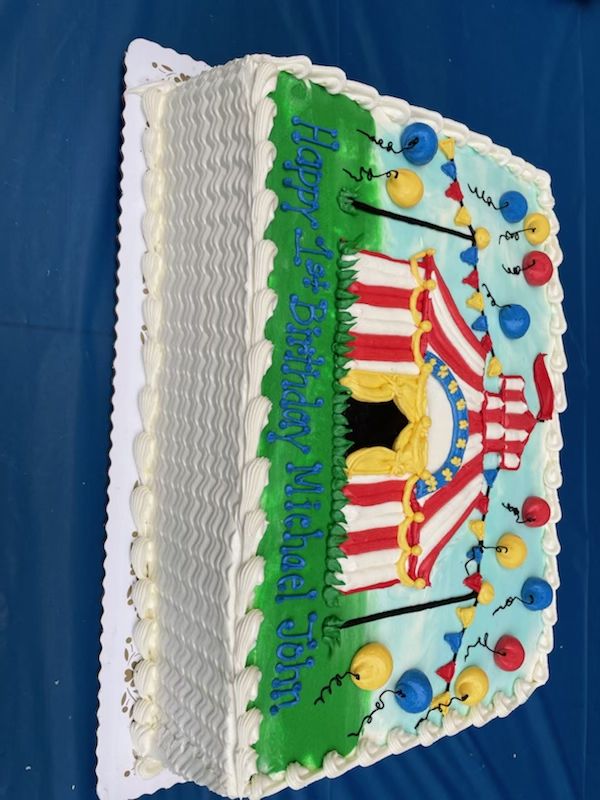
top-left (127, 56), bottom-right (566, 798)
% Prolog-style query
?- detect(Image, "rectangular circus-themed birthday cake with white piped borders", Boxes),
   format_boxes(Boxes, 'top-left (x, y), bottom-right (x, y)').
top-left (126, 56), bottom-right (566, 797)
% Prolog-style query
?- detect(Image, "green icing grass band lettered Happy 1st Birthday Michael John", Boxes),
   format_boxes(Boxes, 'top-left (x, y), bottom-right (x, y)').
top-left (249, 73), bottom-right (381, 772)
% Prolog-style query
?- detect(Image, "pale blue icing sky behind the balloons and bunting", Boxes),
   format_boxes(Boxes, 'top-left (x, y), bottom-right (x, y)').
top-left (358, 123), bottom-right (550, 738)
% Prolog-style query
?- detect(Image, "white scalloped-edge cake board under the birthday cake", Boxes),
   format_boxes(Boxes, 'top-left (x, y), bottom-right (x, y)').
top-left (96, 39), bottom-right (210, 800)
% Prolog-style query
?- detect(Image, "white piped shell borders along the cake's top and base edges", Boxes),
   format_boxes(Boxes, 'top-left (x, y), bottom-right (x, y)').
top-left (119, 56), bottom-right (566, 800)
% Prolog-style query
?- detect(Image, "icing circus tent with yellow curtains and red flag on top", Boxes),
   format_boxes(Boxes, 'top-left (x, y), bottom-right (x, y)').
top-left (338, 250), bottom-right (552, 593)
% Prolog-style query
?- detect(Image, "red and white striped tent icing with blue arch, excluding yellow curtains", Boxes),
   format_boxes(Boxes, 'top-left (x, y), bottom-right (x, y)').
top-left (338, 251), bottom-right (549, 593)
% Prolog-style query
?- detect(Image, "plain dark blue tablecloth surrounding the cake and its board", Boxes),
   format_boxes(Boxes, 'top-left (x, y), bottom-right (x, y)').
top-left (0, 0), bottom-right (600, 800)
